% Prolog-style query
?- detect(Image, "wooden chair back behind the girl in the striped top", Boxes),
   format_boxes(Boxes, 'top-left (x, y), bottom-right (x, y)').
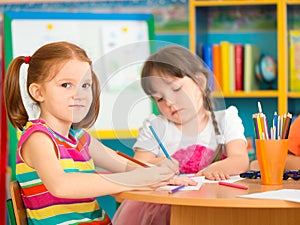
top-left (9, 181), bottom-right (27, 225)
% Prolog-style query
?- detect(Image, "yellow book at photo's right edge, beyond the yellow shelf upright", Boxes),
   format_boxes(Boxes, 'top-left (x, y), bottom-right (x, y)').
top-left (289, 30), bottom-right (300, 91)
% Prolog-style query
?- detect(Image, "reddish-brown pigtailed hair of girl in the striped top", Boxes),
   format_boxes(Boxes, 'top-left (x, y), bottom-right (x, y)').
top-left (4, 42), bottom-right (100, 130)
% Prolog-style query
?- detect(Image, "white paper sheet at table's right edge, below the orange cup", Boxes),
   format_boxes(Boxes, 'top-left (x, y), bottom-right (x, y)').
top-left (239, 189), bottom-right (300, 203)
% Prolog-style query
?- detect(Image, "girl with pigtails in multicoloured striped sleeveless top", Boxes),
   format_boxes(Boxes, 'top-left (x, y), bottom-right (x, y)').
top-left (4, 42), bottom-right (196, 224)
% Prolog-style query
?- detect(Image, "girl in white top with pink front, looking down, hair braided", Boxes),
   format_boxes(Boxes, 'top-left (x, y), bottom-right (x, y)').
top-left (113, 45), bottom-right (249, 225)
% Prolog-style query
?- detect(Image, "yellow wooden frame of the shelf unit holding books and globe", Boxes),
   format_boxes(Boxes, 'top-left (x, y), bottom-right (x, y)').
top-left (189, 0), bottom-right (300, 114)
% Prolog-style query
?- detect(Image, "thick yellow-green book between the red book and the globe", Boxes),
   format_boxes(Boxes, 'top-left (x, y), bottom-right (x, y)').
top-left (244, 44), bottom-right (260, 91)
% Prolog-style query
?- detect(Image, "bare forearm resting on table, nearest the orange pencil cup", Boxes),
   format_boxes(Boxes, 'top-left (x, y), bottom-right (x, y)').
top-left (197, 140), bottom-right (249, 180)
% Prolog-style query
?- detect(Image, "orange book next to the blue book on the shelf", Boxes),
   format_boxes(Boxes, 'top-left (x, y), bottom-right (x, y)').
top-left (212, 44), bottom-right (222, 91)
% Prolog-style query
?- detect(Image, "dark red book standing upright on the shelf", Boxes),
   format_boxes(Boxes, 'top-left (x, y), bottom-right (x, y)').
top-left (234, 44), bottom-right (244, 91)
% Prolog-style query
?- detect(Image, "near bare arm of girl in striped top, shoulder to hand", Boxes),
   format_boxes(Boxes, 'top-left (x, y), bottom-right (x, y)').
top-left (22, 132), bottom-right (174, 198)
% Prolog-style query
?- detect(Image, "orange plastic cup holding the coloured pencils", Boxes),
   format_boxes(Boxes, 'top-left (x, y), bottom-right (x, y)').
top-left (255, 139), bottom-right (288, 185)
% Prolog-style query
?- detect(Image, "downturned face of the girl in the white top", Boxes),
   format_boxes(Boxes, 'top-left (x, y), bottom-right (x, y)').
top-left (150, 76), bottom-right (205, 125)
